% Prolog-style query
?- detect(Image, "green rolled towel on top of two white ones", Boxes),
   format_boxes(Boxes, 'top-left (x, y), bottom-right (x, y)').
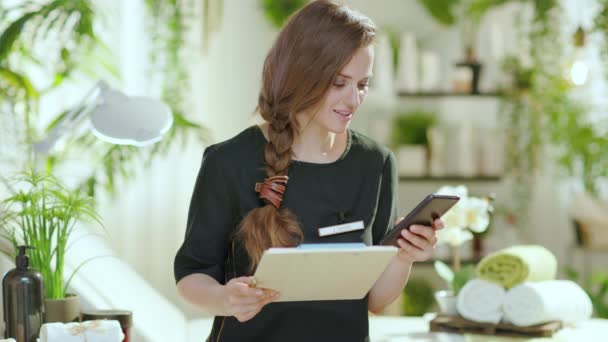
top-left (475, 245), bottom-right (557, 289)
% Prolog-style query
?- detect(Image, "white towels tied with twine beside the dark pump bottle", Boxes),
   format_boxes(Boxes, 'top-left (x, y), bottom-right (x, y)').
top-left (40, 320), bottom-right (125, 342)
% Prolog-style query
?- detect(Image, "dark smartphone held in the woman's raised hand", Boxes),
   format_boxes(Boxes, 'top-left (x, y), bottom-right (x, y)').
top-left (380, 194), bottom-right (460, 247)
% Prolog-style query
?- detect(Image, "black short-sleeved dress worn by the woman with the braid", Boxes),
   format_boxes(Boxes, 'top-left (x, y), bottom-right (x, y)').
top-left (174, 126), bottom-right (397, 342)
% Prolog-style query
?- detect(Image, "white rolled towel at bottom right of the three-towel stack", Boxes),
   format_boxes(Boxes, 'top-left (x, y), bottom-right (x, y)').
top-left (503, 280), bottom-right (593, 326)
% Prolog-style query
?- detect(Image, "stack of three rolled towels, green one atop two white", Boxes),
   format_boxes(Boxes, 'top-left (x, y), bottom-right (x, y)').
top-left (457, 245), bottom-right (593, 326)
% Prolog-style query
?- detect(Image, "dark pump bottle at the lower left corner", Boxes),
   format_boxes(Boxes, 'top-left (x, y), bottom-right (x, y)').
top-left (2, 246), bottom-right (44, 342)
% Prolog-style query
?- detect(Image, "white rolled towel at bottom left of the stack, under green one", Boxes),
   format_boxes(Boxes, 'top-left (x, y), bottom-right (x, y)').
top-left (456, 279), bottom-right (506, 324)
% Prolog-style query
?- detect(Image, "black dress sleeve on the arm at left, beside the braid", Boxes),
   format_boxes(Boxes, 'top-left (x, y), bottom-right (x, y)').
top-left (173, 147), bottom-right (234, 284)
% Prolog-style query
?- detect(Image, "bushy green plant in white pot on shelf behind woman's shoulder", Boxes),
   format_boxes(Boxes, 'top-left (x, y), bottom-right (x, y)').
top-left (391, 110), bottom-right (435, 177)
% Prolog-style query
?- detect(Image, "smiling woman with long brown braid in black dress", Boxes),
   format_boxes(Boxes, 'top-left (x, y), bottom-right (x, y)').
top-left (175, 1), bottom-right (443, 341)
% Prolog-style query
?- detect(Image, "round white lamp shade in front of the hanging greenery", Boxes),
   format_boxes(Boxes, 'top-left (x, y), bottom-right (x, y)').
top-left (90, 88), bottom-right (173, 146)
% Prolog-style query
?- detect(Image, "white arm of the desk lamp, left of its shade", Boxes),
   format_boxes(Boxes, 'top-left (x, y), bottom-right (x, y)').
top-left (34, 81), bottom-right (108, 156)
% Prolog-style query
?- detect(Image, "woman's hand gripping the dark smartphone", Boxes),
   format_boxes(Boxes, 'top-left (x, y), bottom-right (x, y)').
top-left (397, 219), bottom-right (444, 263)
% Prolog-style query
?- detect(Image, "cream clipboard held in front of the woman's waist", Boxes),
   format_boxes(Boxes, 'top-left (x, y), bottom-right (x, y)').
top-left (254, 243), bottom-right (398, 302)
